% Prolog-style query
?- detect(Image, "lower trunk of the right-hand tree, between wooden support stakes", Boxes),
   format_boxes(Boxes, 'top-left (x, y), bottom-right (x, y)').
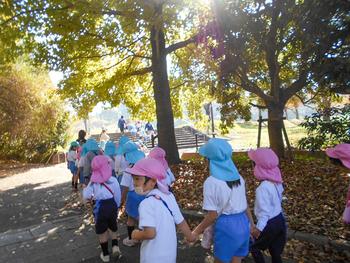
top-left (268, 105), bottom-right (284, 158)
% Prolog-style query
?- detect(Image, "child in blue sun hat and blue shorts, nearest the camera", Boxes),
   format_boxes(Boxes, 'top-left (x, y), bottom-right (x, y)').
top-left (193, 138), bottom-right (252, 262)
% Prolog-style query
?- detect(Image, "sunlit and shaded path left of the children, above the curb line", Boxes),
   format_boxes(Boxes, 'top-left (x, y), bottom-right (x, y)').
top-left (0, 164), bottom-right (80, 232)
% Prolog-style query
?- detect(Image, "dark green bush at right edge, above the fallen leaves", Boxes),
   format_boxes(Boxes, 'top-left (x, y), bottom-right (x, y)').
top-left (299, 104), bottom-right (350, 151)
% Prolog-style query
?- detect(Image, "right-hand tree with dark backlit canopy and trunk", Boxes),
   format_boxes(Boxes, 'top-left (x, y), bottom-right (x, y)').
top-left (200, 0), bottom-right (350, 156)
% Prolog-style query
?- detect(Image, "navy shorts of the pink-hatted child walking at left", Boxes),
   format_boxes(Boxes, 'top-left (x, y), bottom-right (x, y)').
top-left (94, 198), bottom-right (118, 235)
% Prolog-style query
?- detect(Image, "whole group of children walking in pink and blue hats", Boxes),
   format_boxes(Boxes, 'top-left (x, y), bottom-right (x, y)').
top-left (67, 131), bottom-right (350, 263)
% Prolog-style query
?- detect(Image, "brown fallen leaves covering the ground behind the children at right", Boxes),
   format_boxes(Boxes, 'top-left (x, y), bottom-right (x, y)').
top-left (171, 158), bottom-right (350, 241)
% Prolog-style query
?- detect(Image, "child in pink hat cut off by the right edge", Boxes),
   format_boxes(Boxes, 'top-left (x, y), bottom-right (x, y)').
top-left (326, 143), bottom-right (350, 224)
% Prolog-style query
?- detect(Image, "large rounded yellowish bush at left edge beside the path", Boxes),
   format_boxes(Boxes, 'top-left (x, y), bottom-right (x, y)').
top-left (0, 62), bottom-right (69, 162)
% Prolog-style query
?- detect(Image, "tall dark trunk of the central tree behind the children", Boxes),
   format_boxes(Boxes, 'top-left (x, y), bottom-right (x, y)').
top-left (151, 25), bottom-right (180, 164)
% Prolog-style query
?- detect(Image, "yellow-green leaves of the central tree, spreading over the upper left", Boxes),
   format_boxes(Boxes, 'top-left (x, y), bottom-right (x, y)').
top-left (0, 0), bottom-right (212, 120)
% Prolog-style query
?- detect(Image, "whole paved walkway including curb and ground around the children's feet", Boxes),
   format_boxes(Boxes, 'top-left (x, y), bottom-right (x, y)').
top-left (0, 164), bottom-right (290, 263)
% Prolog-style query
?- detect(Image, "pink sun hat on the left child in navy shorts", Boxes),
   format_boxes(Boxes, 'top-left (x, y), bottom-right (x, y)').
top-left (91, 155), bottom-right (112, 184)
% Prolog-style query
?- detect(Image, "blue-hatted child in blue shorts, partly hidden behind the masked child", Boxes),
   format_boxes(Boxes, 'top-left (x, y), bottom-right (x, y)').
top-left (121, 141), bottom-right (145, 247)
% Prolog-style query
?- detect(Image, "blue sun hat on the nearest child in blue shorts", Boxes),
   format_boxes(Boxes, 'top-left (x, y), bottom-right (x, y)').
top-left (199, 138), bottom-right (240, 182)
